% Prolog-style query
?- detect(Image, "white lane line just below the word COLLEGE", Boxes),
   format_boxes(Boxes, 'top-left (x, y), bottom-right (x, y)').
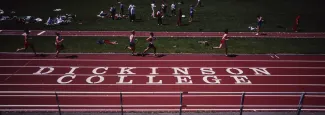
top-left (0, 84), bottom-right (325, 87)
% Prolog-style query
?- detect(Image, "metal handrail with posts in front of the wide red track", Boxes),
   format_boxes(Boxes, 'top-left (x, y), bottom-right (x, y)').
top-left (0, 91), bottom-right (325, 115)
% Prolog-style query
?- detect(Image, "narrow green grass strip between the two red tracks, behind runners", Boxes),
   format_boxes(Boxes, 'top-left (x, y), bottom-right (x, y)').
top-left (0, 36), bottom-right (325, 54)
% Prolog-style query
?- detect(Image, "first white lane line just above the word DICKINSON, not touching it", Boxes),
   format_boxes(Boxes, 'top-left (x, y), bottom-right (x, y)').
top-left (0, 59), bottom-right (325, 63)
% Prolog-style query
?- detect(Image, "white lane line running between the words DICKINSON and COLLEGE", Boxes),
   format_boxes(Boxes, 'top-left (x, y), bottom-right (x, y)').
top-left (0, 74), bottom-right (325, 77)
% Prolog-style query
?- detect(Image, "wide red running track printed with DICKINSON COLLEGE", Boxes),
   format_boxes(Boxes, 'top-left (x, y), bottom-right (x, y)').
top-left (0, 53), bottom-right (325, 111)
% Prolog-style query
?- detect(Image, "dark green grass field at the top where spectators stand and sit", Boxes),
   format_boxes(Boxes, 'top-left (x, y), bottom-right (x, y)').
top-left (0, 0), bottom-right (325, 32)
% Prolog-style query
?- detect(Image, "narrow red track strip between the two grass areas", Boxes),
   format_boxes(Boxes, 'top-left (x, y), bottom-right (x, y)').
top-left (0, 30), bottom-right (325, 38)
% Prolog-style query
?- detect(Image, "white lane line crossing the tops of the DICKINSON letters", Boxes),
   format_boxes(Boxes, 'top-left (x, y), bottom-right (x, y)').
top-left (0, 65), bottom-right (325, 69)
